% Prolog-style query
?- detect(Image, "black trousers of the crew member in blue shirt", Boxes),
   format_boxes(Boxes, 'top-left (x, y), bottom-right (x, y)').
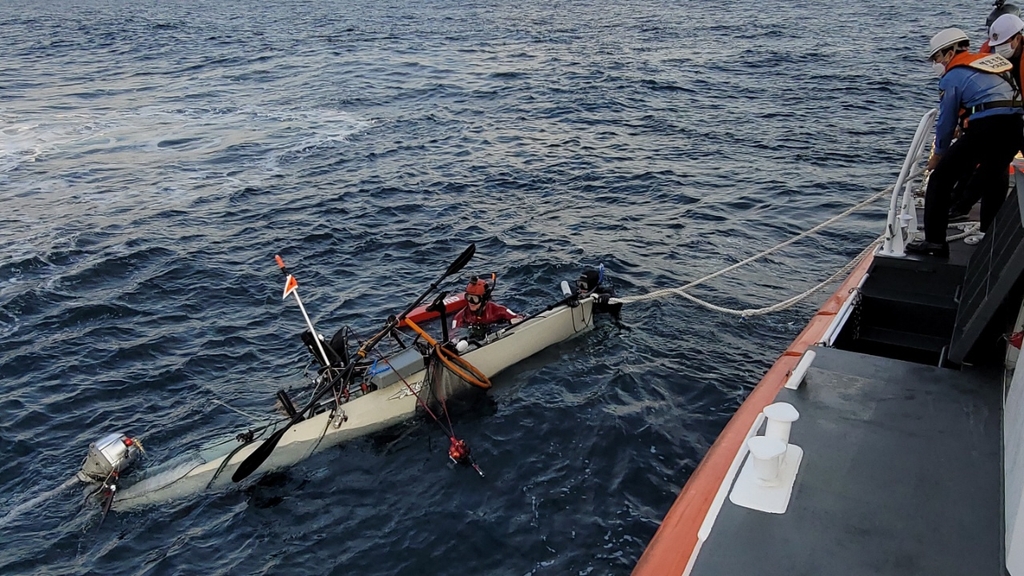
top-left (925, 114), bottom-right (1024, 244)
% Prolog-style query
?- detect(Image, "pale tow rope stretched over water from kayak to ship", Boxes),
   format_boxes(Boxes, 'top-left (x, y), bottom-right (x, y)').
top-left (609, 187), bottom-right (893, 318)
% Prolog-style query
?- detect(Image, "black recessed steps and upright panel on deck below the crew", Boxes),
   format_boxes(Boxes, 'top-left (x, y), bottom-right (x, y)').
top-left (836, 172), bottom-right (1024, 369)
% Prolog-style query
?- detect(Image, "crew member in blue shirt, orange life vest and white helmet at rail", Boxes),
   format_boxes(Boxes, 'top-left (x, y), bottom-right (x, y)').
top-left (906, 28), bottom-right (1024, 257)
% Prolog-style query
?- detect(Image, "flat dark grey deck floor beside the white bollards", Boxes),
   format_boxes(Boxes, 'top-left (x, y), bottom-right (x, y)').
top-left (692, 347), bottom-right (1002, 576)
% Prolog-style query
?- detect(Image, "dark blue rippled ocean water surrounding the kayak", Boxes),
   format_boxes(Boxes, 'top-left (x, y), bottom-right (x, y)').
top-left (0, 0), bottom-right (989, 575)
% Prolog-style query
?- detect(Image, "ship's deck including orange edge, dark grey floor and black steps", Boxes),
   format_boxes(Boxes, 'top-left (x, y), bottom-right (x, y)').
top-left (634, 162), bottom-right (1024, 576)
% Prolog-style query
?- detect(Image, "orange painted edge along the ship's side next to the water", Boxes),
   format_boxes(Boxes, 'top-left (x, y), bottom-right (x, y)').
top-left (633, 254), bottom-right (873, 576)
